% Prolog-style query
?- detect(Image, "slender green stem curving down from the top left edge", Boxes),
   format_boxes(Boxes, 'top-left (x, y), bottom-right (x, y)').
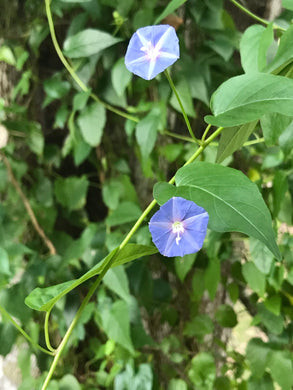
top-left (45, 0), bottom-right (139, 122)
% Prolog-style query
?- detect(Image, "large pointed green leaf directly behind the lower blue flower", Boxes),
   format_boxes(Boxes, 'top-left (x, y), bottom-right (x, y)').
top-left (154, 162), bottom-right (281, 259)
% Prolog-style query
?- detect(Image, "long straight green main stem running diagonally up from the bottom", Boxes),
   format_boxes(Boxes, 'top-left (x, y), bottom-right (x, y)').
top-left (41, 125), bottom-right (223, 390)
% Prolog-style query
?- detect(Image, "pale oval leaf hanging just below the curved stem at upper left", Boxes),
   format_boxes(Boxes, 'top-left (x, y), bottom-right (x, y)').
top-left (77, 102), bottom-right (106, 147)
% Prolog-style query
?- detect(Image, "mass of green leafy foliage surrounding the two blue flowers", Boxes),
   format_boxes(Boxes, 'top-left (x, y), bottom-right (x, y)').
top-left (0, 0), bottom-right (293, 390)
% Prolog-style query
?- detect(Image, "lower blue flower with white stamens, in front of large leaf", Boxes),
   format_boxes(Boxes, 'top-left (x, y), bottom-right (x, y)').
top-left (149, 197), bottom-right (209, 257)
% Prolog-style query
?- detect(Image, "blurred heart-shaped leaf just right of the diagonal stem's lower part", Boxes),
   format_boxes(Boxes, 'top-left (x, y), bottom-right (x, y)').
top-left (101, 301), bottom-right (134, 354)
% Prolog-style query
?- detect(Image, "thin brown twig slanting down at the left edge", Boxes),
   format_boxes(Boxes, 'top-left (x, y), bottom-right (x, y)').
top-left (0, 153), bottom-right (56, 255)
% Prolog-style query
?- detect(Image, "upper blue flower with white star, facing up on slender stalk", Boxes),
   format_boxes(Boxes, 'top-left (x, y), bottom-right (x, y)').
top-left (125, 24), bottom-right (179, 80)
